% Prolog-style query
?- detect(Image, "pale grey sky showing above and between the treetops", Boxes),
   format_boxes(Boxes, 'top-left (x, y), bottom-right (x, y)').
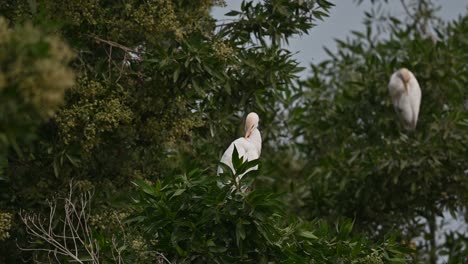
top-left (212, 0), bottom-right (468, 78)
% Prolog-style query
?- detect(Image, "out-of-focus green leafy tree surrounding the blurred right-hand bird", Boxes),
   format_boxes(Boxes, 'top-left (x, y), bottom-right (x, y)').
top-left (293, 4), bottom-right (468, 264)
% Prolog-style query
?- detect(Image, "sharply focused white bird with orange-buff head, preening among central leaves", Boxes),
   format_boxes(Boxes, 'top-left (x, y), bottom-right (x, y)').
top-left (218, 112), bottom-right (262, 180)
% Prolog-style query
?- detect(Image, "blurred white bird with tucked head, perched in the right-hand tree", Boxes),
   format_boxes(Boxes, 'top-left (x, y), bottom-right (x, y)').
top-left (388, 68), bottom-right (421, 131)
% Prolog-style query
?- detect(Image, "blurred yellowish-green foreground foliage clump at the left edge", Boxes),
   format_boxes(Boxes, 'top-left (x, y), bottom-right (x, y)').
top-left (0, 18), bottom-right (74, 159)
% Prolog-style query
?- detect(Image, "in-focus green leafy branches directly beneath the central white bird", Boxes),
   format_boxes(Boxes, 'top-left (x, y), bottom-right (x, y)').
top-left (128, 160), bottom-right (403, 263)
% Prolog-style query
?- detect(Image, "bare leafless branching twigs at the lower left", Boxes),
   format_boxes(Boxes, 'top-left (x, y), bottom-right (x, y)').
top-left (18, 180), bottom-right (171, 264)
